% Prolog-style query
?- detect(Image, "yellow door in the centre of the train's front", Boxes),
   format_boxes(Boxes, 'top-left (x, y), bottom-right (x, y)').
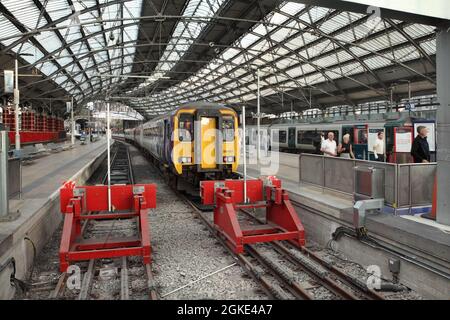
top-left (201, 117), bottom-right (217, 169)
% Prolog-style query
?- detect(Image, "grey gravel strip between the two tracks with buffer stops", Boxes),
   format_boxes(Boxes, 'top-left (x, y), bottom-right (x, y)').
top-left (130, 147), bottom-right (267, 300)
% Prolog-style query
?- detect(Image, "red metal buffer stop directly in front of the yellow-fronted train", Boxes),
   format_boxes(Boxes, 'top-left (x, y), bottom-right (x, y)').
top-left (200, 177), bottom-right (305, 254)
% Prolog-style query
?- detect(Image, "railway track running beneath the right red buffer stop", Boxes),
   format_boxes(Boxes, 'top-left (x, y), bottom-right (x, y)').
top-left (181, 195), bottom-right (384, 300)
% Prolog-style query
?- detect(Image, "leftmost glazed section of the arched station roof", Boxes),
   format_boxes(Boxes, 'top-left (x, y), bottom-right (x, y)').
top-left (0, 0), bottom-right (142, 101)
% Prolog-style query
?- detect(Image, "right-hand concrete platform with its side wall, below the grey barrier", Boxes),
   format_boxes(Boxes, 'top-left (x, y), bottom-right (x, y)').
top-left (240, 156), bottom-right (450, 299)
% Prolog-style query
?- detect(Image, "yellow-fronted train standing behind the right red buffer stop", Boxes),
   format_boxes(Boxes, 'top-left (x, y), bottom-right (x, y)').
top-left (131, 103), bottom-right (239, 184)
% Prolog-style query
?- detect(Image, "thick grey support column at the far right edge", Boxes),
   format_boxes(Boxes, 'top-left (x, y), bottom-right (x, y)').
top-left (436, 30), bottom-right (450, 225)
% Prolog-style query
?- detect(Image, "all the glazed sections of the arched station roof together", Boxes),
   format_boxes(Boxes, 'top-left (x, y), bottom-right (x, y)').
top-left (0, 0), bottom-right (436, 117)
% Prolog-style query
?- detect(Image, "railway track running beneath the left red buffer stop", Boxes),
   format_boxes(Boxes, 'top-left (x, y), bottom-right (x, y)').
top-left (49, 142), bottom-right (158, 300)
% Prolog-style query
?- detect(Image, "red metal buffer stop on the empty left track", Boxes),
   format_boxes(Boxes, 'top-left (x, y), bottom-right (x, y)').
top-left (59, 182), bottom-right (156, 272)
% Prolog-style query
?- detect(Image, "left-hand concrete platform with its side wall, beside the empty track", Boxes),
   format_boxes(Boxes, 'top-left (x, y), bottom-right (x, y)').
top-left (0, 139), bottom-right (106, 299)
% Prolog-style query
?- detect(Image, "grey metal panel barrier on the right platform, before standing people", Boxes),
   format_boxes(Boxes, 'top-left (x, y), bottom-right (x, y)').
top-left (299, 154), bottom-right (437, 208)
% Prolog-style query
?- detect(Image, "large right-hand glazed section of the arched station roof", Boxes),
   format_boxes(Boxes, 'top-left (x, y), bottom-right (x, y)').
top-left (133, 1), bottom-right (436, 113)
